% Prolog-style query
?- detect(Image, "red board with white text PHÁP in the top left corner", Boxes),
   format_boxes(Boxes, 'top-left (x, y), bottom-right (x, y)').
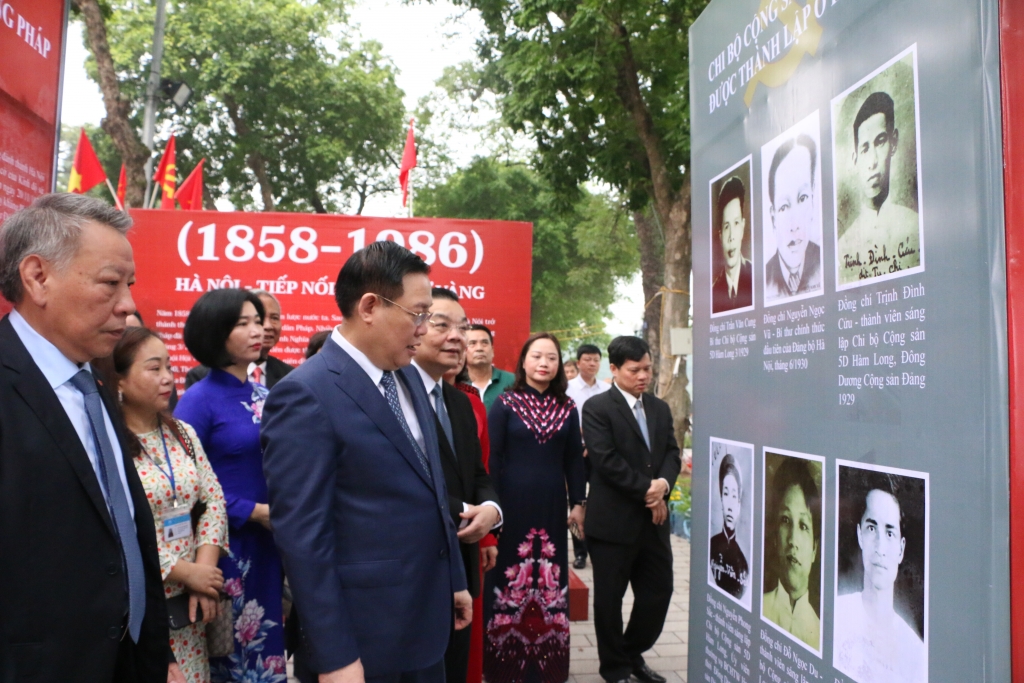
top-left (0, 0), bottom-right (68, 222)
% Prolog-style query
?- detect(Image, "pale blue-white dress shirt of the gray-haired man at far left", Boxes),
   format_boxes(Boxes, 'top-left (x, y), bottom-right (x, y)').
top-left (10, 310), bottom-right (135, 518)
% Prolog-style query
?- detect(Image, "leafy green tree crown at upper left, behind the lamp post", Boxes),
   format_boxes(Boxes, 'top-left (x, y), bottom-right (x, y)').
top-left (96, 0), bottom-right (404, 212)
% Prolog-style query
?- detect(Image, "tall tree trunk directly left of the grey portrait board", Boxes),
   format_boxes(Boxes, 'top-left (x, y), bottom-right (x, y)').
top-left (614, 25), bottom-right (692, 445)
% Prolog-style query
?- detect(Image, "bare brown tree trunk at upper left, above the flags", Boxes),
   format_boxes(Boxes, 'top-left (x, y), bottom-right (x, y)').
top-left (72, 0), bottom-right (150, 208)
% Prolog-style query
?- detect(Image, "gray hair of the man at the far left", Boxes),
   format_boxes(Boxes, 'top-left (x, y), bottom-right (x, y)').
top-left (0, 193), bottom-right (132, 304)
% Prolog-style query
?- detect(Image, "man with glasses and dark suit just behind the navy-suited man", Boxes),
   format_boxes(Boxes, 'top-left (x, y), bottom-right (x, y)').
top-left (401, 287), bottom-right (501, 683)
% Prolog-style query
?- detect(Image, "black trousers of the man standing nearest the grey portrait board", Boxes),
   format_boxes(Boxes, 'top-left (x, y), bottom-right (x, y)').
top-left (587, 523), bottom-right (672, 681)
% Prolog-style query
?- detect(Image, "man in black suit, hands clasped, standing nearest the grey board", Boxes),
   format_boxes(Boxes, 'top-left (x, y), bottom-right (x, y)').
top-left (583, 337), bottom-right (682, 683)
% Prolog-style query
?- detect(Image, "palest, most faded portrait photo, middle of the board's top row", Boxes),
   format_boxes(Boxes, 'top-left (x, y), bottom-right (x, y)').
top-left (761, 112), bottom-right (824, 306)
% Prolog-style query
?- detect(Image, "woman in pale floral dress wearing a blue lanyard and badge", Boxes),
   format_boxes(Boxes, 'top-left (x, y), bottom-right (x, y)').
top-left (104, 328), bottom-right (227, 683)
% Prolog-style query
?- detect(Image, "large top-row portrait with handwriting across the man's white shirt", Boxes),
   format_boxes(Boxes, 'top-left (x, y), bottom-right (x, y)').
top-left (831, 45), bottom-right (925, 290)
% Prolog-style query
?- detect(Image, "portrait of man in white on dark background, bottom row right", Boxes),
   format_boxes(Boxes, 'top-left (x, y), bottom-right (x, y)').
top-left (833, 460), bottom-right (929, 683)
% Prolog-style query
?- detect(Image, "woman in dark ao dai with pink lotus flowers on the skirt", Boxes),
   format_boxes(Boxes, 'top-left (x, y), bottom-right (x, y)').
top-left (483, 333), bottom-right (587, 683)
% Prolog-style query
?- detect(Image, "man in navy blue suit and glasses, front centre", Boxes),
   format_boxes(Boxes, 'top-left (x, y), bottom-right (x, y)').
top-left (261, 242), bottom-right (472, 683)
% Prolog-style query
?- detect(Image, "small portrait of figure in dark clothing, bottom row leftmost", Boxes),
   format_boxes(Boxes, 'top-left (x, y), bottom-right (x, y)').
top-left (708, 437), bottom-right (754, 610)
